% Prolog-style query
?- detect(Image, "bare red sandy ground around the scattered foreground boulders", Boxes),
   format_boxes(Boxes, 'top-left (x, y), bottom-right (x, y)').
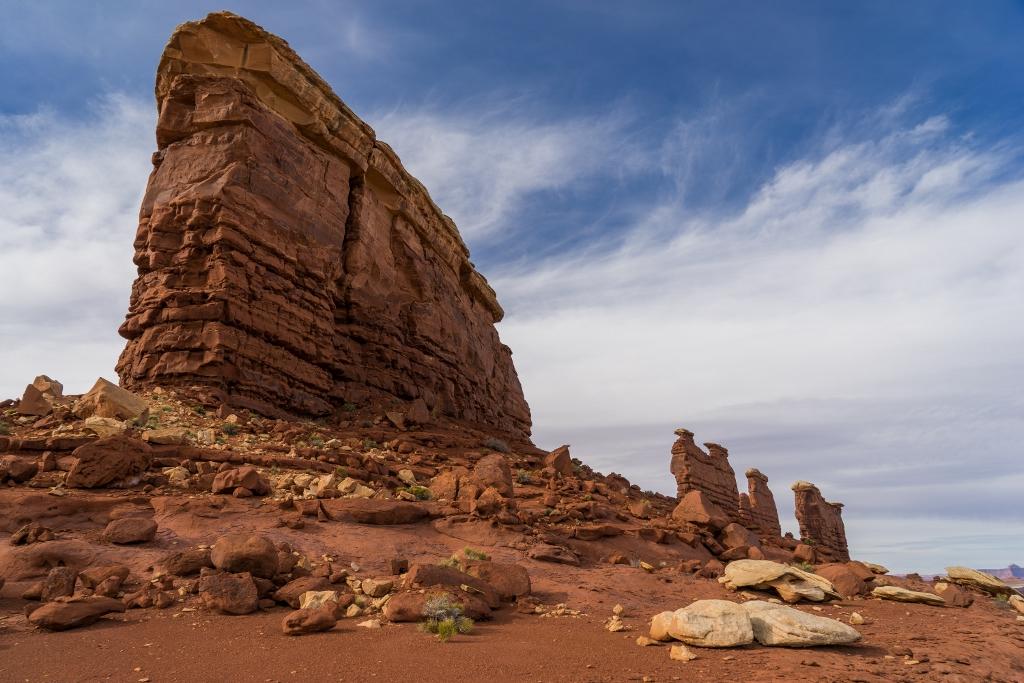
top-left (0, 489), bottom-right (1024, 683)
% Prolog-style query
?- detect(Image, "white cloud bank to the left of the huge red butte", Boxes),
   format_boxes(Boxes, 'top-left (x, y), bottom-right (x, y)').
top-left (0, 94), bottom-right (156, 396)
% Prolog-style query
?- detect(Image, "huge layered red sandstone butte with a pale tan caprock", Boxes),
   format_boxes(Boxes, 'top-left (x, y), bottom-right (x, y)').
top-left (118, 12), bottom-right (530, 438)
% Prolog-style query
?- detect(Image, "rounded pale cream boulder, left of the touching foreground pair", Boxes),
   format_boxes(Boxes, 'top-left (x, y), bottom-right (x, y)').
top-left (651, 600), bottom-right (754, 647)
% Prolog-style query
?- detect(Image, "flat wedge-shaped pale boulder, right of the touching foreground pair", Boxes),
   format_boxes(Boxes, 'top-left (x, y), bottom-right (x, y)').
top-left (742, 600), bottom-right (860, 647)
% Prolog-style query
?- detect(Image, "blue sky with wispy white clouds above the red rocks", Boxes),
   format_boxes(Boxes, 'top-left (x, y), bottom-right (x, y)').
top-left (0, 1), bottom-right (1024, 571)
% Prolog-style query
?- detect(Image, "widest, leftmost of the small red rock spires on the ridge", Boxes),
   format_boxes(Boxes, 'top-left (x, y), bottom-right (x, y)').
top-left (672, 429), bottom-right (739, 521)
